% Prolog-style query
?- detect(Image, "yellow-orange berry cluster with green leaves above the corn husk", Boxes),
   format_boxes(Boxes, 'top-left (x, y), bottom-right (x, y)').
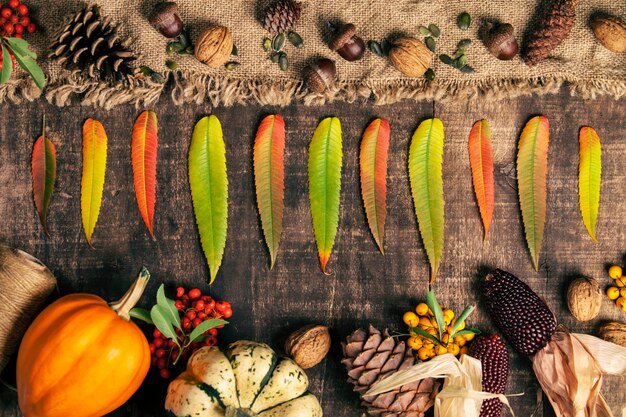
top-left (402, 303), bottom-right (474, 361)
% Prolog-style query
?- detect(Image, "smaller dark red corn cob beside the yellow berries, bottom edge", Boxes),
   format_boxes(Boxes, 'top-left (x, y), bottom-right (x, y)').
top-left (469, 334), bottom-right (509, 417)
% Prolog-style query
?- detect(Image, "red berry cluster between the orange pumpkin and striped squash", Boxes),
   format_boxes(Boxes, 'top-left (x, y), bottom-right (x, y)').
top-left (149, 287), bottom-right (233, 379)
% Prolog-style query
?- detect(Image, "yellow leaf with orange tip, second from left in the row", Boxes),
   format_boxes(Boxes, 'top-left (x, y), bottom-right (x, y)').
top-left (80, 119), bottom-right (107, 246)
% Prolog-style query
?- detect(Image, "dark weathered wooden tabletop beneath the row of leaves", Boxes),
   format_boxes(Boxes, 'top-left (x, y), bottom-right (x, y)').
top-left (0, 91), bottom-right (626, 417)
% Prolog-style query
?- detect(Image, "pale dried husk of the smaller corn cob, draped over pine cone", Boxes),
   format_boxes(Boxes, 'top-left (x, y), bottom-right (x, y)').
top-left (365, 353), bottom-right (515, 417)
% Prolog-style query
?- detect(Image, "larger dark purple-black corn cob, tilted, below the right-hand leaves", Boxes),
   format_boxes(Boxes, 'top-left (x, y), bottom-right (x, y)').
top-left (483, 269), bottom-right (556, 356)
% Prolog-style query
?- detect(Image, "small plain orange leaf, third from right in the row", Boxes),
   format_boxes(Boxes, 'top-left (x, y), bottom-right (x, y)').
top-left (468, 119), bottom-right (495, 239)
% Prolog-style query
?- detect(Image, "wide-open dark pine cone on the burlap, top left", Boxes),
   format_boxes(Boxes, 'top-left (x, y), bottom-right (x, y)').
top-left (48, 5), bottom-right (137, 81)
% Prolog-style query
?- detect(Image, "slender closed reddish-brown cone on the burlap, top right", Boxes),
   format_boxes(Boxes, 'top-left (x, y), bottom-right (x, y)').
top-left (522, 0), bottom-right (576, 67)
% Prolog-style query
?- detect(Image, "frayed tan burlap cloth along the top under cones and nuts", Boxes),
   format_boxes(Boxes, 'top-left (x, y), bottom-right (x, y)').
top-left (0, 0), bottom-right (626, 107)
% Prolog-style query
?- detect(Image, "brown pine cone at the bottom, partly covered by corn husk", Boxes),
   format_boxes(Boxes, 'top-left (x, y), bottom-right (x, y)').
top-left (341, 325), bottom-right (439, 417)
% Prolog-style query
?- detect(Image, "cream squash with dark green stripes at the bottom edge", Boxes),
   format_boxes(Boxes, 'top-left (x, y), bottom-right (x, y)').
top-left (165, 340), bottom-right (322, 417)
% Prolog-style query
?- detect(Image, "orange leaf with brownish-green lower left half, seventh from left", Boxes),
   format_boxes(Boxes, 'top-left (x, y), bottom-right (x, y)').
top-left (360, 119), bottom-right (389, 255)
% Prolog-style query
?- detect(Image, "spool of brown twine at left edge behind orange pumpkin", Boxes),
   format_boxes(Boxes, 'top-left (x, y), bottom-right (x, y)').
top-left (0, 245), bottom-right (56, 371)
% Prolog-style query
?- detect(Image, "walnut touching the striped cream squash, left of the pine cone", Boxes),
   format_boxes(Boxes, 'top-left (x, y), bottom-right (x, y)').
top-left (285, 324), bottom-right (331, 369)
